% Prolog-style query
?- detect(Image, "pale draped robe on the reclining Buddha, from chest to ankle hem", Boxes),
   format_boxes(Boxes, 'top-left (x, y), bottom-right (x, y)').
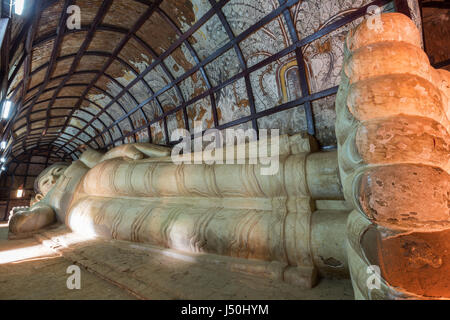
top-left (59, 135), bottom-right (346, 286)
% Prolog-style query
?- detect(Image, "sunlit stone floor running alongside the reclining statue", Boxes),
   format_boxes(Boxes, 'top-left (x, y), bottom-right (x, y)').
top-left (0, 225), bottom-right (353, 300)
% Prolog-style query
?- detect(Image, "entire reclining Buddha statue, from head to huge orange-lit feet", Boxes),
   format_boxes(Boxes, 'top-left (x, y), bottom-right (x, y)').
top-left (10, 13), bottom-right (450, 299)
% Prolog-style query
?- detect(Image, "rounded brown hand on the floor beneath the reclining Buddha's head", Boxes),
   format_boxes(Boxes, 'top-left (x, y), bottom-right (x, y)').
top-left (9, 204), bottom-right (55, 234)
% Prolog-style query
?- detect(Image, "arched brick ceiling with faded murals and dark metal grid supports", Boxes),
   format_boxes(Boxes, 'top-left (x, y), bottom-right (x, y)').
top-left (4, 0), bottom-right (420, 165)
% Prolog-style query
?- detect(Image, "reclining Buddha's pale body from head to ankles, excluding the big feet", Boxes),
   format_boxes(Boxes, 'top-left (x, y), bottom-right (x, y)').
top-left (10, 134), bottom-right (348, 287)
